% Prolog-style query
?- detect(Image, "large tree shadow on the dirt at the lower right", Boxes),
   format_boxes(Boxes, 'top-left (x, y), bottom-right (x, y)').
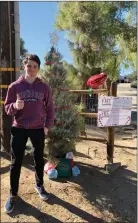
top-left (54, 163), bottom-right (137, 223)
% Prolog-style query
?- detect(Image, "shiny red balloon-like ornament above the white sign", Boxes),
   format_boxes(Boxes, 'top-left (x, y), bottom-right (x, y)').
top-left (87, 73), bottom-right (107, 89)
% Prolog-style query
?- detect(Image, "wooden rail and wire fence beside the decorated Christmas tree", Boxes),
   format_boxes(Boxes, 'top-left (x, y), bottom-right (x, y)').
top-left (69, 79), bottom-right (117, 163)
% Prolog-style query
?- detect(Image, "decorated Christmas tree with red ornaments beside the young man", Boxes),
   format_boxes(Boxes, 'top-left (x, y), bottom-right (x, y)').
top-left (41, 33), bottom-right (82, 158)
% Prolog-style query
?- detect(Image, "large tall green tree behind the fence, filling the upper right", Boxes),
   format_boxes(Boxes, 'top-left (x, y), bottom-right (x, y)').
top-left (55, 2), bottom-right (136, 85)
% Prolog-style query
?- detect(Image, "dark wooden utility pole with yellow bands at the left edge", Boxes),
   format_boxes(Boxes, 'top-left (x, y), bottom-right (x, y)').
top-left (0, 1), bottom-right (16, 153)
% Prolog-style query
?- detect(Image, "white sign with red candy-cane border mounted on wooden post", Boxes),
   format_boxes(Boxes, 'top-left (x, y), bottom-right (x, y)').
top-left (97, 96), bottom-right (132, 127)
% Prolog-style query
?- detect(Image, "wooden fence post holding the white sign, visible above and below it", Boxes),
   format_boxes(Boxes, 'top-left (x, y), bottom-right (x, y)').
top-left (107, 81), bottom-right (117, 163)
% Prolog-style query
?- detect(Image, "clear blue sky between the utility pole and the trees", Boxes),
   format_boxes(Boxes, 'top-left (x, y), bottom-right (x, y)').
top-left (19, 2), bottom-right (132, 75)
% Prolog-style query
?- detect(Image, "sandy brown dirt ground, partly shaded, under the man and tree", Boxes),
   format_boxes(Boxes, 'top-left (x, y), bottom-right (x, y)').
top-left (1, 126), bottom-right (137, 223)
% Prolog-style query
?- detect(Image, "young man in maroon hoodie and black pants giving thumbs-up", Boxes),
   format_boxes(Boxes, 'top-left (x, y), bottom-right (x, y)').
top-left (5, 54), bottom-right (54, 213)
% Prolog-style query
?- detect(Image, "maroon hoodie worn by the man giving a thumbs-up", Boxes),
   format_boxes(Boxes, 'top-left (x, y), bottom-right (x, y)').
top-left (5, 76), bottom-right (54, 129)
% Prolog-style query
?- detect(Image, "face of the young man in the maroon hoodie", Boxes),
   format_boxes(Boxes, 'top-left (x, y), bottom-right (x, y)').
top-left (24, 60), bottom-right (39, 77)
